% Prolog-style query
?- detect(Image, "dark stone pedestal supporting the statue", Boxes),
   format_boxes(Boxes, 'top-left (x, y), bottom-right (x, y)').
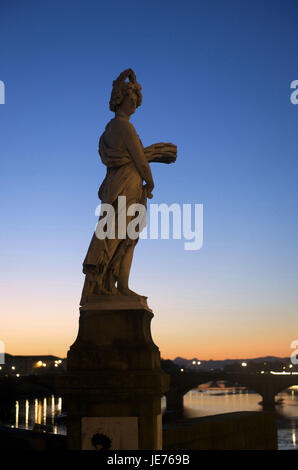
top-left (57, 295), bottom-right (169, 450)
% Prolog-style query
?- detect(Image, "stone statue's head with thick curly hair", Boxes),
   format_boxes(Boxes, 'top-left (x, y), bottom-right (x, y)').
top-left (110, 69), bottom-right (142, 115)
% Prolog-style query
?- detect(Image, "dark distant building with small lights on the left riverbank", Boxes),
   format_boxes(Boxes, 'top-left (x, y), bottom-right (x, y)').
top-left (0, 354), bottom-right (66, 376)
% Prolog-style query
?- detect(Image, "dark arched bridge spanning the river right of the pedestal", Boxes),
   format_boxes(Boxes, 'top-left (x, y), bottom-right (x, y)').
top-left (165, 369), bottom-right (298, 412)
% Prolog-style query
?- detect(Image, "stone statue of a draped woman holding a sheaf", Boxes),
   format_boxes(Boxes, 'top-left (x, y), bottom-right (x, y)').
top-left (80, 69), bottom-right (177, 305)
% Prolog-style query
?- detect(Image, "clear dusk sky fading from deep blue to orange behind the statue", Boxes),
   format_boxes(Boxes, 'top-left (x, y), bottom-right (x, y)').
top-left (0, 0), bottom-right (298, 360)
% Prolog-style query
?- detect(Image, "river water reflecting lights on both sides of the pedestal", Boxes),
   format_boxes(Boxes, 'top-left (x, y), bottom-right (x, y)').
top-left (0, 387), bottom-right (298, 450)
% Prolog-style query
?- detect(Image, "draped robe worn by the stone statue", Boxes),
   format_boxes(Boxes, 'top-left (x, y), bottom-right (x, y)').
top-left (81, 116), bottom-right (146, 305)
